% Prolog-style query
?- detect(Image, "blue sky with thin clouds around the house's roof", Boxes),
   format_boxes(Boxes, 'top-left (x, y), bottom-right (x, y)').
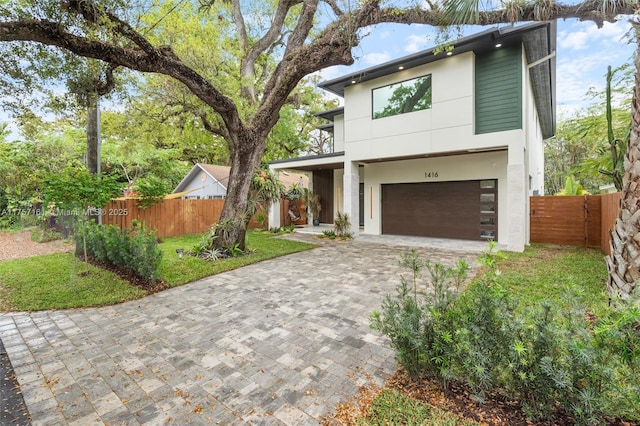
top-left (321, 19), bottom-right (635, 120)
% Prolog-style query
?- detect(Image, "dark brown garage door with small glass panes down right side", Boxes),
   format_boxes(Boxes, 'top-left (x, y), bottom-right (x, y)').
top-left (382, 180), bottom-right (498, 240)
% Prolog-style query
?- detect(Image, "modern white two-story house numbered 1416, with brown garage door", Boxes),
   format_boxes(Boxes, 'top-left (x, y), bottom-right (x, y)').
top-left (270, 22), bottom-right (556, 251)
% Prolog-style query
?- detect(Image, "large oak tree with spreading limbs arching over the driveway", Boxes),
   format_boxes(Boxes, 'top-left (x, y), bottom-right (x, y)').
top-left (0, 0), bottom-right (640, 262)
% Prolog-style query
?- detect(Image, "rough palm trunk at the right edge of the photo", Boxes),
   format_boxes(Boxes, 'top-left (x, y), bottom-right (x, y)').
top-left (606, 25), bottom-right (640, 298)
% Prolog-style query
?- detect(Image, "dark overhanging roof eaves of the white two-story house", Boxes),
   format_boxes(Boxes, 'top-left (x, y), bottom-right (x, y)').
top-left (316, 21), bottom-right (556, 139)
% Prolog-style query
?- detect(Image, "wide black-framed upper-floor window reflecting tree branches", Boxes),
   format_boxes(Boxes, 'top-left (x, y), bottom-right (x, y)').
top-left (373, 75), bottom-right (431, 118)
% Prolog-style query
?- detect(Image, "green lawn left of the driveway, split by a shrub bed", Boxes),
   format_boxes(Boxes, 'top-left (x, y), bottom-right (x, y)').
top-left (0, 231), bottom-right (315, 311)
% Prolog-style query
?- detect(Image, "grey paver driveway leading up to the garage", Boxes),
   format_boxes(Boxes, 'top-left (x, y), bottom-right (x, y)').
top-left (0, 234), bottom-right (486, 426)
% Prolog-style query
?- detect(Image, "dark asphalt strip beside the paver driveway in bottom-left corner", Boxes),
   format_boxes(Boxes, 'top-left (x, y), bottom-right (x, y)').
top-left (0, 339), bottom-right (31, 425)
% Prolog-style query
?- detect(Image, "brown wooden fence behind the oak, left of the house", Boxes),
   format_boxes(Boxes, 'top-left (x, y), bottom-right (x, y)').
top-left (102, 199), bottom-right (260, 238)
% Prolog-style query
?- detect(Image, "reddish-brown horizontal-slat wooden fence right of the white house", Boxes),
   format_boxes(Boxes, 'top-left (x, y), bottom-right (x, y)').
top-left (529, 192), bottom-right (621, 254)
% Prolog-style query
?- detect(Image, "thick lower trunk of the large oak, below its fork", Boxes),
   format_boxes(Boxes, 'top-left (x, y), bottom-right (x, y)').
top-left (214, 136), bottom-right (266, 250)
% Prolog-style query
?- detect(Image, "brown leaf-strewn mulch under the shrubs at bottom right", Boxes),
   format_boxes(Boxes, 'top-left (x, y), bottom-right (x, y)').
top-left (322, 371), bottom-right (638, 426)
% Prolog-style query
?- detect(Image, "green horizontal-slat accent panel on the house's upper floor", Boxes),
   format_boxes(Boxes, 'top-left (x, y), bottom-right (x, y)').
top-left (475, 46), bottom-right (522, 134)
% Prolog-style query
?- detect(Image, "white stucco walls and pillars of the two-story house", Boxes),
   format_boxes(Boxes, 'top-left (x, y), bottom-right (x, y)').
top-left (272, 23), bottom-right (556, 251)
